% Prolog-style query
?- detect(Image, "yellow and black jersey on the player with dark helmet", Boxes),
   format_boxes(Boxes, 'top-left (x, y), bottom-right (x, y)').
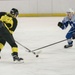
top-left (0, 12), bottom-right (18, 34)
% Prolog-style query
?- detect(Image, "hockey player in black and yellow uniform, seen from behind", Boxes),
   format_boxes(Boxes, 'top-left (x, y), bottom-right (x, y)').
top-left (0, 8), bottom-right (23, 61)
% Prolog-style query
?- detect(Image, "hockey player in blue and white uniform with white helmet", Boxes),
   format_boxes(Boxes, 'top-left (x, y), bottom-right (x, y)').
top-left (58, 9), bottom-right (75, 48)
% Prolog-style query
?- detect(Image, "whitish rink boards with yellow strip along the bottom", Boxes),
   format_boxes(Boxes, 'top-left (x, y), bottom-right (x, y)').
top-left (0, 0), bottom-right (75, 17)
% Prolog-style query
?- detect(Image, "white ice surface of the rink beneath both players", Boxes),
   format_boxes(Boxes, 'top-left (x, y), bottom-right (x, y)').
top-left (0, 17), bottom-right (75, 75)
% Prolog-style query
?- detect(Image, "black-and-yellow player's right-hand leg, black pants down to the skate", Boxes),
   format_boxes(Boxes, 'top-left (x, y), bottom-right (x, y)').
top-left (0, 22), bottom-right (23, 61)
